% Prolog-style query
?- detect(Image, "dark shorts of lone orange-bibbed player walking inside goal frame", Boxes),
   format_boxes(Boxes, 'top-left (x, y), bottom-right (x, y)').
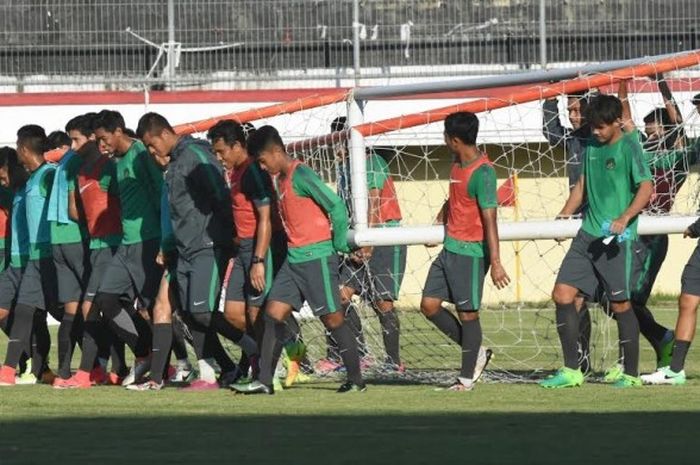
top-left (423, 249), bottom-right (488, 312)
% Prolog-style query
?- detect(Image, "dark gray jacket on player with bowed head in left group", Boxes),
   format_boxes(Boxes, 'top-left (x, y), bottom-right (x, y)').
top-left (165, 136), bottom-right (233, 257)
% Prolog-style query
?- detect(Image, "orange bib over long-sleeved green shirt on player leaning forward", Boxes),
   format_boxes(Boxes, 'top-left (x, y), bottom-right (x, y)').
top-left (275, 160), bottom-right (348, 263)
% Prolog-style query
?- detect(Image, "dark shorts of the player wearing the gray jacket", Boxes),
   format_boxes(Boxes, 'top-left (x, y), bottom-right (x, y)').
top-left (175, 249), bottom-right (227, 313)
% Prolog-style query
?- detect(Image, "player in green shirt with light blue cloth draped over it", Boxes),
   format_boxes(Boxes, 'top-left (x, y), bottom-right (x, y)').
top-left (47, 122), bottom-right (89, 379)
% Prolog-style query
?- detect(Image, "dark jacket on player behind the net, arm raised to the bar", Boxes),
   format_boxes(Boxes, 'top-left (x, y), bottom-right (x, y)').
top-left (542, 99), bottom-right (591, 189)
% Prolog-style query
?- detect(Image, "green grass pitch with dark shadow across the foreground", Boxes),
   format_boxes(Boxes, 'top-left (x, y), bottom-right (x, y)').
top-left (0, 300), bottom-right (700, 465)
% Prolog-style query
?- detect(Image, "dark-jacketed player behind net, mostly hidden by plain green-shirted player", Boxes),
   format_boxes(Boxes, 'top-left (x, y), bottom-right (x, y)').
top-left (542, 94), bottom-right (591, 373)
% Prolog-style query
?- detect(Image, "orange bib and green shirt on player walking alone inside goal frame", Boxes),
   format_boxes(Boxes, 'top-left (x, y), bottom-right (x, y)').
top-left (444, 154), bottom-right (498, 257)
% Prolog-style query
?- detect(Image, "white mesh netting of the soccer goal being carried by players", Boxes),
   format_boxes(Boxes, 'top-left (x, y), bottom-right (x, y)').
top-left (189, 54), bottom-right (700, 382)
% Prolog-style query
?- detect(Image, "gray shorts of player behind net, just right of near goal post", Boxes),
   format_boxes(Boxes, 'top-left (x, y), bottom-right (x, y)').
top-left (340, 245), bottom-right (407, 301)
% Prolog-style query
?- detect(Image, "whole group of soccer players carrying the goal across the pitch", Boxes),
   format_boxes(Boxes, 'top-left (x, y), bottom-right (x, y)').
top-left (0, 79), bottom-right (700, 394)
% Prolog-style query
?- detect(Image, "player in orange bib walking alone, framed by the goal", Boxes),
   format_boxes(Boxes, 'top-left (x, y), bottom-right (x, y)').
top-left (421, 112), bottom-right (510, 391)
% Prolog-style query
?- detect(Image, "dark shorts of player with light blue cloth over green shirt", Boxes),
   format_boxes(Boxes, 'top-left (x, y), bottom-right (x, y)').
top-left (53, 242), bottom-right (90, 304)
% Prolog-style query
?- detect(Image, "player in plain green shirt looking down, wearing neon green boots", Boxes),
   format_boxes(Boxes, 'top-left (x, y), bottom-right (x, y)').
top-left (540, 95), bottom-right (653, 388)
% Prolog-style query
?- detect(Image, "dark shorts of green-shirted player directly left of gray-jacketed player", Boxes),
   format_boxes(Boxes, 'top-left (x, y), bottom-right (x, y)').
top-left (97, 239), bottom-right (163, 309)
